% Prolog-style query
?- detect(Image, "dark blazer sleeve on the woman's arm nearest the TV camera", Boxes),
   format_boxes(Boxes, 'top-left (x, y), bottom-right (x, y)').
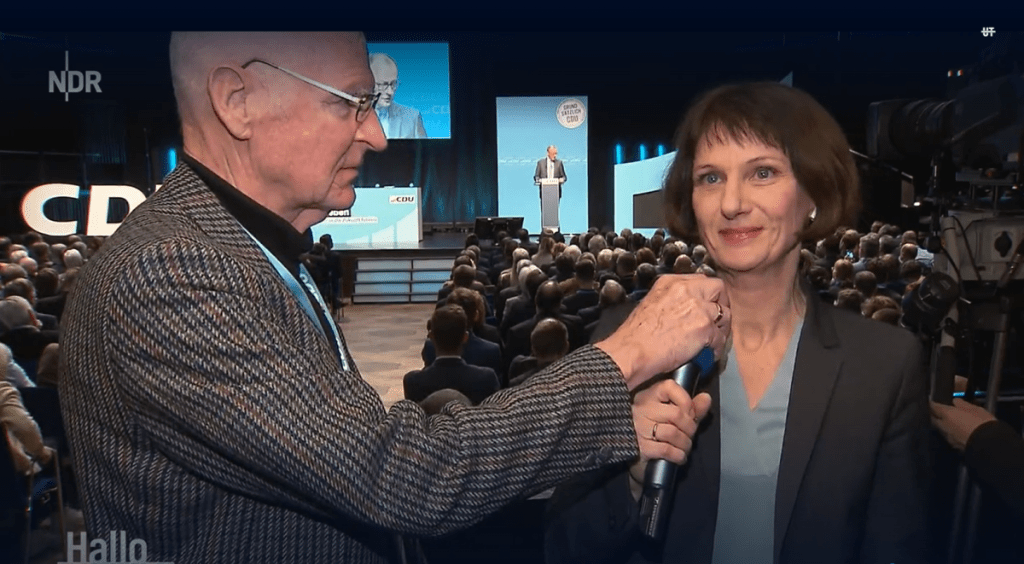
top-left (860, 339), bottom-right (930, 564)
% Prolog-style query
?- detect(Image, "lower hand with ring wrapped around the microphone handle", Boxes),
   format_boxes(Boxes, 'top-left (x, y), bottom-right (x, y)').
top-left (630, 380), bottom-right (711, 500)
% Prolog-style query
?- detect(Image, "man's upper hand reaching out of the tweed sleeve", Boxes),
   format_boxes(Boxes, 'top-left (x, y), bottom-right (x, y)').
top-left (596, 274), bottom-right (732, 390)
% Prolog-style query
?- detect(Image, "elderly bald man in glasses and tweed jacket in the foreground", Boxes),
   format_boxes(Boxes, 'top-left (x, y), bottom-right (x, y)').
top-left (60, 33), bottom-right (729, 564)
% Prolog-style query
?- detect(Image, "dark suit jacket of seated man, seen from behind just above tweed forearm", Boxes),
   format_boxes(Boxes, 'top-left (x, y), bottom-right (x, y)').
top-left (401, 356), bottom-right (499, 405)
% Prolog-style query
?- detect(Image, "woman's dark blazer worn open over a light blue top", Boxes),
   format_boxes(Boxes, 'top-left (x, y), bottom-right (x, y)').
top-left (546, 290), bottom-right (929, 564)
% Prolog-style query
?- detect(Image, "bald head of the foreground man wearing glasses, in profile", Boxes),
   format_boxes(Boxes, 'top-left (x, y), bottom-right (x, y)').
top-left (170, 32), bottom-right (387, 232)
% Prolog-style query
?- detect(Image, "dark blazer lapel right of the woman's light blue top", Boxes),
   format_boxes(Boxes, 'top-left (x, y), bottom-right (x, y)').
top-left (774, 291), bottom-right (842, 562)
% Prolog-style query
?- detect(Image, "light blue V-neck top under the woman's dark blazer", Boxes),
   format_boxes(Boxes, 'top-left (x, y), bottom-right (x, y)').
top-left (712, 321), bottom-right (804, 564)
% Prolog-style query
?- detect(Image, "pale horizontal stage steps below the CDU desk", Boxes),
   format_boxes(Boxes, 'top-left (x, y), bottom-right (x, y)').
top-left (352, 251), bottom-right (455, 304)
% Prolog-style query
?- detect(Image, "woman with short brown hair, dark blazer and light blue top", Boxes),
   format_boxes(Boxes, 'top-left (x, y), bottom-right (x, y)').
top-left (546, 83), bottom-right (928, 564)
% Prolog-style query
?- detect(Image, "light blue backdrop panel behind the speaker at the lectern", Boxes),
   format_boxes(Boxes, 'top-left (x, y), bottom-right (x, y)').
top-left (498, 96), bottom-right (590, 233)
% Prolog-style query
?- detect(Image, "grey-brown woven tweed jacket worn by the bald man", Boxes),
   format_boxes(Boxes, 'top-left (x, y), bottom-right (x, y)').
top-left (59, 164), bottom-right (639, 564)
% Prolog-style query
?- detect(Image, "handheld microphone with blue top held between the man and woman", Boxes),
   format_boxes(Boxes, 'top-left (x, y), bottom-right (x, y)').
top-left (640, 347), bottom-right (715, 539)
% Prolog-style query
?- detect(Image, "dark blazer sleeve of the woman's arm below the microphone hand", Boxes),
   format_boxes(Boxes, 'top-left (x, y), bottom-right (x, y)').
top-left (544, 465), bottom-right (640, 564)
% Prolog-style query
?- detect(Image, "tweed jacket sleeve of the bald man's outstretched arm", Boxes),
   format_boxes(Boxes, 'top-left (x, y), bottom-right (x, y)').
top-left (100, 241), bottom-right (638, 535)
